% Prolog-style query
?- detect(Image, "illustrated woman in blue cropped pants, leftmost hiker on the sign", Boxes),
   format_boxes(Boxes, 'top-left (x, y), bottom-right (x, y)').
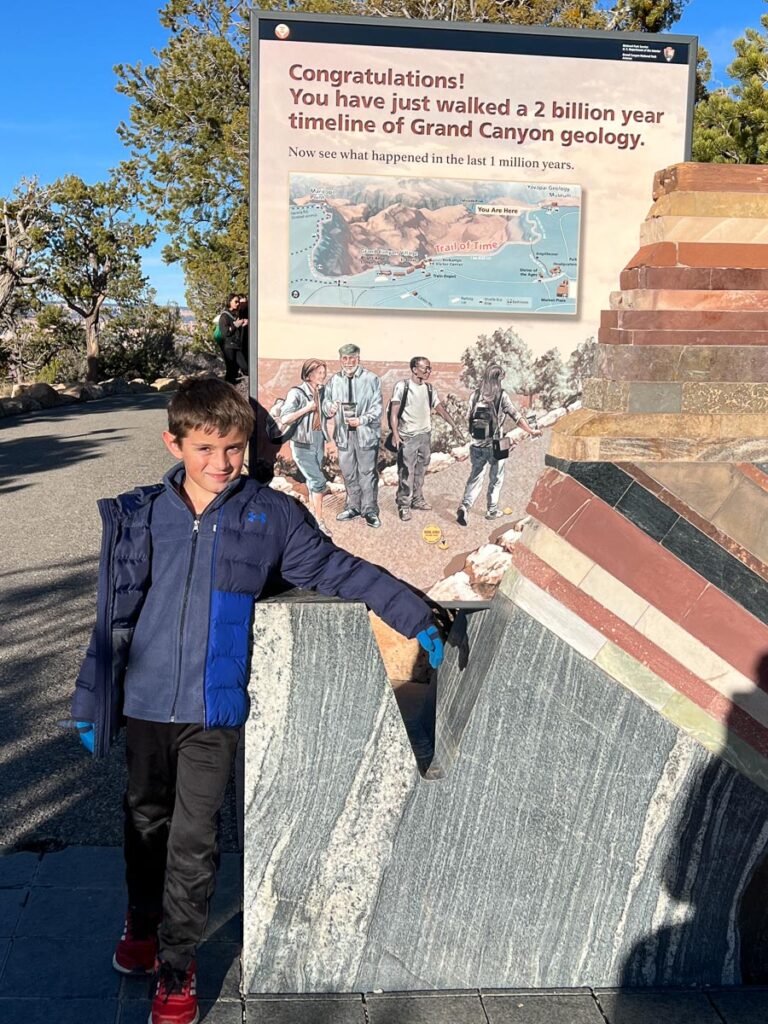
top-left (272, 359), bottom-right (332, 537)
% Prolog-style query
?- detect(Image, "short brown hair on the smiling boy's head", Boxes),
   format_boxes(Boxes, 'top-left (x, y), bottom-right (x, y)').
top-left (168, 377), bottom-right (255, 441)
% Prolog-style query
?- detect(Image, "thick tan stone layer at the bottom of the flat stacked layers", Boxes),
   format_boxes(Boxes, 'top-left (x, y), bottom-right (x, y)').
top-left (549, 409), bottom-right (768, 462)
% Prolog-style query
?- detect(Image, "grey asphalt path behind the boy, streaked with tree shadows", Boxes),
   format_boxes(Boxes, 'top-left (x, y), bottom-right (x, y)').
top-left (0, 395), bottom-right (237, 850)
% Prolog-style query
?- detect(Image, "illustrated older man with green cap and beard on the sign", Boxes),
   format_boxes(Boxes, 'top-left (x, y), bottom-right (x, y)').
top-left (323, 344), bottom-right (382, 527)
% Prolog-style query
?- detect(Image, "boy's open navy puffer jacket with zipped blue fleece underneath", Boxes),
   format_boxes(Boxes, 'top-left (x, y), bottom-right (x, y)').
top-left (72, 465), bottom-right (433, 757)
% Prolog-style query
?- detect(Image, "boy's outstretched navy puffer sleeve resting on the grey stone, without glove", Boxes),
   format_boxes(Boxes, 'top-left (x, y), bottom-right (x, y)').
top-left (281, 501), bottom-right (441, 638)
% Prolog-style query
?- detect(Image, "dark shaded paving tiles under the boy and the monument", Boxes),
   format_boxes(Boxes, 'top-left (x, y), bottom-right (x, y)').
top-left (0, 846), bottom-right (768, 1024)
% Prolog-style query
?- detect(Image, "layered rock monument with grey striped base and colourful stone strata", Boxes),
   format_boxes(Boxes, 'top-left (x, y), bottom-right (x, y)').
top-left (244, 164), bottom-right (768, 993)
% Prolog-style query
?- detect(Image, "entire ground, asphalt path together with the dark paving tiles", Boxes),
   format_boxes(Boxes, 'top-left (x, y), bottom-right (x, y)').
top-left (0, 395), bottom-right (768, 1024)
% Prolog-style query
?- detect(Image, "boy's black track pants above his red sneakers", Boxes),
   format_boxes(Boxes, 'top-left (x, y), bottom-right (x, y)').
top-left (124, 718), bottom-right (240, 969)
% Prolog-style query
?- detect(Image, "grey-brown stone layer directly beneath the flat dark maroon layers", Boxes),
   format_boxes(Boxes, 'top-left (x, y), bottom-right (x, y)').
top-left (583, 345), bottom-right (768, 387)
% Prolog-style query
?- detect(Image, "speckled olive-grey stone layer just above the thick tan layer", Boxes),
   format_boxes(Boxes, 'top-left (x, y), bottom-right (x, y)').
top-left (582, 375), bottom-right (768, 414)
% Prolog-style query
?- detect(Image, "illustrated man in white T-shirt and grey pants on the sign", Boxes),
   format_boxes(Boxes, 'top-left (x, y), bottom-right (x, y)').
top-left (389, 355), bottom-right (459, 522)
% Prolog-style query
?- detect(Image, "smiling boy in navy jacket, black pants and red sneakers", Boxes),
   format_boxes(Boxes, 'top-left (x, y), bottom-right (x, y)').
top-left (73, 379), bottom-right (442, 1024)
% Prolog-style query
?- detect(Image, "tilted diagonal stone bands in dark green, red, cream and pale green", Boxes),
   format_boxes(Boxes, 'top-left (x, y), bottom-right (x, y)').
top-left (512, 460), bottom-right (768, 787)
